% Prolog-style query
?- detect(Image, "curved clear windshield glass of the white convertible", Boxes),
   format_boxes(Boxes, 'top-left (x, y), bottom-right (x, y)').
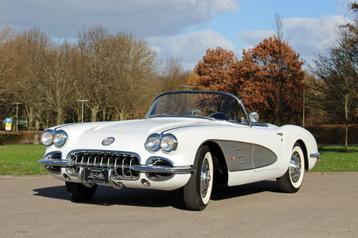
top-left (147, 91), bottom-right (247, 124)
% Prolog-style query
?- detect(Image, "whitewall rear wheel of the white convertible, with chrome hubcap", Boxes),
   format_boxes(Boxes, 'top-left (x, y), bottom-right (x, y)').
top-left (277, 144), bottom-right (305, 193)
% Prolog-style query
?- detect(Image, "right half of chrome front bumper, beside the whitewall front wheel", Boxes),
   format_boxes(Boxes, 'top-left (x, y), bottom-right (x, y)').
top-left (131, 165), bottom-right (193, 174)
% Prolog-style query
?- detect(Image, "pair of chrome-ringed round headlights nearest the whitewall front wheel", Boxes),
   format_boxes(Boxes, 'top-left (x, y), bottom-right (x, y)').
top-left (144, 133), bottom-right (178, 153)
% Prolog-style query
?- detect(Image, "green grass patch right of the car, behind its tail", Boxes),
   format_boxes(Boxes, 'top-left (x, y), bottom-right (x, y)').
top-left (313, 146), bottom-right (358, 172)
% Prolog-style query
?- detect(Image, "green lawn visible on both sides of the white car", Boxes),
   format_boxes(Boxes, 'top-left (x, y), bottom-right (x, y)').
top-left (0, 145), bottom-right (358, 175)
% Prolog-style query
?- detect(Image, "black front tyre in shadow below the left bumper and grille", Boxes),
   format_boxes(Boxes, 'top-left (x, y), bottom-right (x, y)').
top-left (66, 182), bottom-right (97, 202)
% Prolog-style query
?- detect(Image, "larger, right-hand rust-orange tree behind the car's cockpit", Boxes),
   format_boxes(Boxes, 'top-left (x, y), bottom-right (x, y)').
top-left (238, 36), bottom-right (304, 125)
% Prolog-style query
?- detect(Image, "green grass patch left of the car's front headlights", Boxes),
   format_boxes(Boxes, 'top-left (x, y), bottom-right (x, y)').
top-left (0, 145), bottom-right (46, 175)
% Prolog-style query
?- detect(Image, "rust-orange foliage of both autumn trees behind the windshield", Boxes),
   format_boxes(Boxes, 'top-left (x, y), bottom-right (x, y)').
top-left (190, 37), bottom-right (304, 124)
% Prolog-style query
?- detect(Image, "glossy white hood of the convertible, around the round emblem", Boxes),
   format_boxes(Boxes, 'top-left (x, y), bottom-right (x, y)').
top-left (50, 118), bottom-right (212, 151)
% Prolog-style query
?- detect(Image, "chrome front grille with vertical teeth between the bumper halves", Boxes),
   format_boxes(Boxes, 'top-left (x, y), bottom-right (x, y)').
top-left (69, 150), bottom-right (139, 180)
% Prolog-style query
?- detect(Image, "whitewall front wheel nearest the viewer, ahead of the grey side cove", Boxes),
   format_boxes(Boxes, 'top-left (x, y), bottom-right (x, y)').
top-left (183, 146), bottom-right (214, 211)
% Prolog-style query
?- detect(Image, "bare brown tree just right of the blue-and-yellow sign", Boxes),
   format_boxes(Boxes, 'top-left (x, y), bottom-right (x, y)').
top-left (11, 29), bottom-right (50, 129)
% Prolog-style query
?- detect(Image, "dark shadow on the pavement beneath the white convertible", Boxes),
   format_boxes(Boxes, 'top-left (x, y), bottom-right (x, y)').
top-left (33, 181), bottom-right (279, 209)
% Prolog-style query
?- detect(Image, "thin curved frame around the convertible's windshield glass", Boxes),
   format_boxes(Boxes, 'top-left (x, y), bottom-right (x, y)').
top-left (145, 90), bottom-right (251, 126)
